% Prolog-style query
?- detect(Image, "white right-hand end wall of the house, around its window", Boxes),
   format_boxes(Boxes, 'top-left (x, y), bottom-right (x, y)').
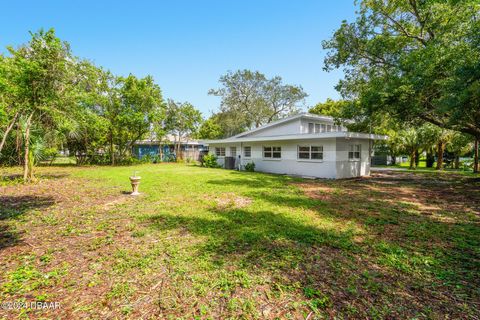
top-left (336, 138), bottom-right (370, 179)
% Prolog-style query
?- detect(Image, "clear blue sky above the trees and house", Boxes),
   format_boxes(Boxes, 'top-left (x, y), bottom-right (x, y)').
top-left (0, 0), bottom-right (355, 116)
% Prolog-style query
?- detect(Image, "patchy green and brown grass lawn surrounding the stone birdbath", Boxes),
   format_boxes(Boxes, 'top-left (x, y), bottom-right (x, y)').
top-left (0, 164), bottom-right (480, 319)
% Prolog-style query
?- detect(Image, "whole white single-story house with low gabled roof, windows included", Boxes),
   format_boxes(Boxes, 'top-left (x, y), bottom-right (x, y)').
top-left (204, 113), bottom-right (387, 179)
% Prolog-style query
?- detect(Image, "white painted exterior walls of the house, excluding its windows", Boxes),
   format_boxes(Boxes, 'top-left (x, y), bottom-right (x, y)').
top-left (208, 115), bottom-right (382, 179)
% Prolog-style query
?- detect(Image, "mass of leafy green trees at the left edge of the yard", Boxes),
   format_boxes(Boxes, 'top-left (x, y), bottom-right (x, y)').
top-left (0, 29), bottom-right (166, 170)
